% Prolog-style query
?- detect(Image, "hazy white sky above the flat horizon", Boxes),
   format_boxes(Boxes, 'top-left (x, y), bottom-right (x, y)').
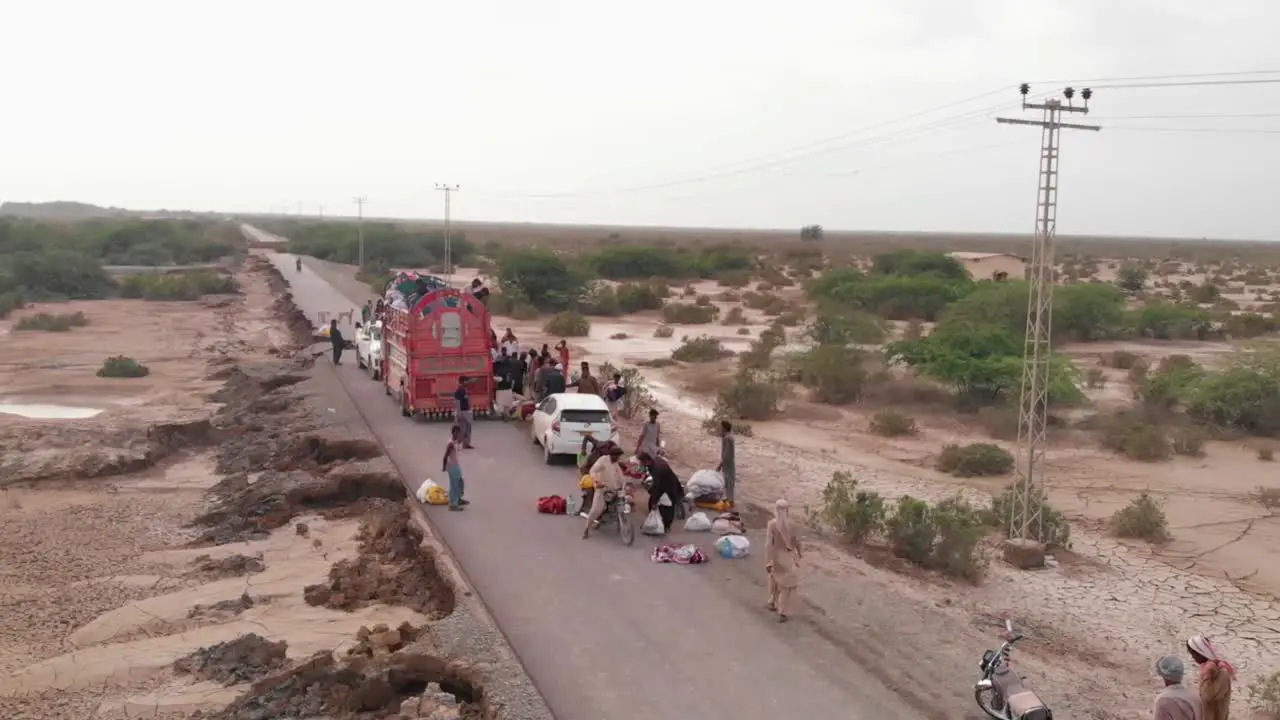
top-left (0, 0), bottom-right (1280, 238)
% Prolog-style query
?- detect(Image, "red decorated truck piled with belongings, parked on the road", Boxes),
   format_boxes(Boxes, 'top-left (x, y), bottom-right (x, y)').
top-left (381, 273), bottom-right (494, 419)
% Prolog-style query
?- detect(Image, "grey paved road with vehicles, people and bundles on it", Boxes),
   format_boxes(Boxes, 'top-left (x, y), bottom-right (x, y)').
top-left (271, 254), bottom-right (931, 720)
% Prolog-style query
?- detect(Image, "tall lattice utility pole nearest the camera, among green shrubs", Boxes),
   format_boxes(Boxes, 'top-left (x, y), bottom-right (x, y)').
top-left (996, 83), bottom-right (1102, 569)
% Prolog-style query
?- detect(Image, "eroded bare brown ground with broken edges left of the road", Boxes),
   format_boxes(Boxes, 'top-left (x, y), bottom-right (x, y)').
top-left (0, 260), bottom-right (494, 720)
